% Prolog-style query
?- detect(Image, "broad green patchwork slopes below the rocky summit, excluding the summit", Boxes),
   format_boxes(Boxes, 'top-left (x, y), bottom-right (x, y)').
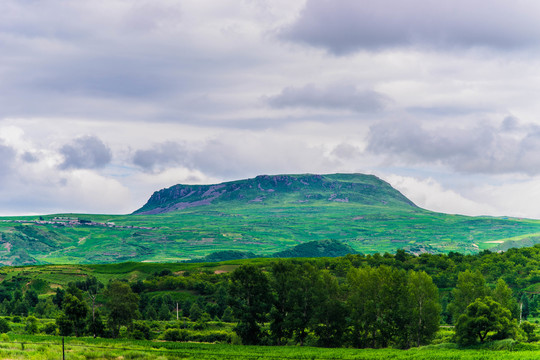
top-left (0, 204), bottom-right (540, 265)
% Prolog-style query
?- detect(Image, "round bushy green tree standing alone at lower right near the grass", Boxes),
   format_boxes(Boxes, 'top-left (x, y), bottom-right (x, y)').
top-left (456, 296), bottom-right (517, 346)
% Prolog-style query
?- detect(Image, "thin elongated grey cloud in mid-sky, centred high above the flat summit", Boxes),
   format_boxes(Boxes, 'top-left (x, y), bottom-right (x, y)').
top-left (266, 84), bottom-right (390, 112)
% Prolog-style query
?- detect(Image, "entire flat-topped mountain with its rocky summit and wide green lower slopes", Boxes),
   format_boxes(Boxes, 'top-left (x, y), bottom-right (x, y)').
top-left (0, 174), bottom-right (540, 265)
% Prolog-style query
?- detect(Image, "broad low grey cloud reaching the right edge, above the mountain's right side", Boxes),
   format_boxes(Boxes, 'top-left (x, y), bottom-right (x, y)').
top-left (367, 118), bottom-right (540, 175)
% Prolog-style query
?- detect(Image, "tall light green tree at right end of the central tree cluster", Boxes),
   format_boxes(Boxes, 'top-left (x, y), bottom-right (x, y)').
top-left (407, 271), bottom-right (441, 346)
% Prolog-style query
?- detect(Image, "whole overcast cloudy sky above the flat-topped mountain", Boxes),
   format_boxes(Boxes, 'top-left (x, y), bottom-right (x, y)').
top-left (0, 0), bottom-right (540, 219)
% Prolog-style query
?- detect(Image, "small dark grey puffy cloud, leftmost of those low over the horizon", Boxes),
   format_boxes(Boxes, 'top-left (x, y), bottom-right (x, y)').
top-left (60, 136), bottom-right (112, 169)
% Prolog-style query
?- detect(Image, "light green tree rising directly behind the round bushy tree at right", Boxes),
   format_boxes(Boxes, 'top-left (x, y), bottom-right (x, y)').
top-left (448, 270), bottom-right (488, 322)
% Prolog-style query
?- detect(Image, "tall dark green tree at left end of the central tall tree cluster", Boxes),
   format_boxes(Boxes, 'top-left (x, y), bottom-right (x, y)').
top-left (229, 264), bottom-right (271, 345)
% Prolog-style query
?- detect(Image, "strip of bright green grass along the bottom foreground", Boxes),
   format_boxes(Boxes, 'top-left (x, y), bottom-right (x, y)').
top-left (0, 335), bottom-right (540, 360)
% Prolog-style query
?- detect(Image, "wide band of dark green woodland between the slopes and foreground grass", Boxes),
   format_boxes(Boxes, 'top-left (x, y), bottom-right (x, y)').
top-left (0, 246), bottom-right (540, 358)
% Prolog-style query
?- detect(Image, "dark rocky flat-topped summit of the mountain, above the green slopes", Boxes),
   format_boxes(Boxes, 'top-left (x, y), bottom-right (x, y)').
top-left (134, 174), bottom-right (416, 214)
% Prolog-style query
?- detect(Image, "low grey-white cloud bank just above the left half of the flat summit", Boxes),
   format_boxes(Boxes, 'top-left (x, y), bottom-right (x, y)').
top-left (133, 134), bottom-right (331, 179)
